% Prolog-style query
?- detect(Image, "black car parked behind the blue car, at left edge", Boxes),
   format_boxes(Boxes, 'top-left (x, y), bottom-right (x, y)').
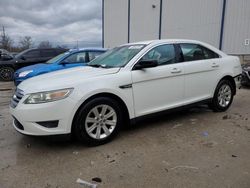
top-left (0, 48), bottom-right (68, 81)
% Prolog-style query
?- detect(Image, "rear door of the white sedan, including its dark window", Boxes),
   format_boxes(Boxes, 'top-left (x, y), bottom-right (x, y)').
top-left (179, 43), bottom-right (220, 104)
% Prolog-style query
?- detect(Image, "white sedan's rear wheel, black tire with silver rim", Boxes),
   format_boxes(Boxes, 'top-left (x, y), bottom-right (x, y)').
top-left (209, 80), bottom-right (234, 112)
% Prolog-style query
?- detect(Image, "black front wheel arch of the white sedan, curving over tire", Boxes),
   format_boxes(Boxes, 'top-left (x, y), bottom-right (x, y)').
top-left (71, 92), bottom-right (130, 132)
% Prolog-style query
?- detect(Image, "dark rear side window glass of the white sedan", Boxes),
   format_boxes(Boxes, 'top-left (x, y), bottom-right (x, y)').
top-left (180, 44), bottom-right (219, 61)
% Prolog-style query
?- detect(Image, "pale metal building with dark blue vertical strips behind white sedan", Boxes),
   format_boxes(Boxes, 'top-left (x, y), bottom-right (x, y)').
top-left (103, 0), bottom-right (250, 55)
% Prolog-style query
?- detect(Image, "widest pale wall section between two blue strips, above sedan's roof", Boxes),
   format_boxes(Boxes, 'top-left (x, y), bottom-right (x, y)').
top-left (162, 0), bottom-right (223, 48)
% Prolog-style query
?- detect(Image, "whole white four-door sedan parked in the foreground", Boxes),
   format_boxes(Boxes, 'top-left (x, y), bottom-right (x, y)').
top-left (10, 40), bottom-right (242, 144)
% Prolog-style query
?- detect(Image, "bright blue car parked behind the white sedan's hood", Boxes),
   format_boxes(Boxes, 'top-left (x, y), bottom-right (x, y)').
top-left (14, 48), bottom-right (106, 86)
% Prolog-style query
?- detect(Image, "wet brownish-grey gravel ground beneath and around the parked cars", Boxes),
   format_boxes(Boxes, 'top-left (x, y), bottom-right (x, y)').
top-left (0, 82), bottom-right (250, 188)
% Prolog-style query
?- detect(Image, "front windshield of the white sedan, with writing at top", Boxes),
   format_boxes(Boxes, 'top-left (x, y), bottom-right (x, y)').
top-left (88, 44), bottom-right (145, 68)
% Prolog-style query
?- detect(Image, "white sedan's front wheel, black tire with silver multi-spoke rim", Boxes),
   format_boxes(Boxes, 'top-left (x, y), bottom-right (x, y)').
top-left (72, 97), bottom-right (122, 146)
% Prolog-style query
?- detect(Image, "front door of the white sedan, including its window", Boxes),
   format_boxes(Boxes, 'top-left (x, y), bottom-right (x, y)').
top-left (132, 44), bottom-right (184, 117)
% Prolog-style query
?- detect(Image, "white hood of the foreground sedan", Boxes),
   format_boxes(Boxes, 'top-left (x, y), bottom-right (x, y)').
top-left (18, 66), bottom-right (120, 94)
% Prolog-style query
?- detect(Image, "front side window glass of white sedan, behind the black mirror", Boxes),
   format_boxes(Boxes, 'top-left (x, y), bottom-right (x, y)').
top-left (142, 44), bottom-right (176, 65)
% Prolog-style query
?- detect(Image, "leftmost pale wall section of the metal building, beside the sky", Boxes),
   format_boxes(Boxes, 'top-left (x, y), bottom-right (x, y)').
top-left (103, 0), bottom-right (128, 48)
